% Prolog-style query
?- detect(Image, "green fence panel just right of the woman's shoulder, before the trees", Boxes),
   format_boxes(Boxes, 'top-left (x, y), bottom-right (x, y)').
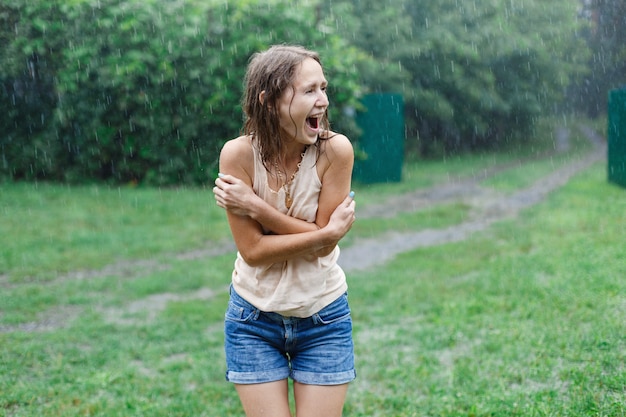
top-left (354, 94), bottom-right (404, 184)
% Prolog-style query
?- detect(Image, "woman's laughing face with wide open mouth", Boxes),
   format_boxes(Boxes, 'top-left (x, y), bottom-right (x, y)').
top-left (278, 58), bottom-right (328, 145)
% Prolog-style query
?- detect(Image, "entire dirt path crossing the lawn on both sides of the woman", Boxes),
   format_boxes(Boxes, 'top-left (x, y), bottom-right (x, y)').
top-left (0, 126), bottom-right (606, 333)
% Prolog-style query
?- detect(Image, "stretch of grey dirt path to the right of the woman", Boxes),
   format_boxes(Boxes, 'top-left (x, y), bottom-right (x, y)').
top-left (339, 126), bottom-right (606, 272)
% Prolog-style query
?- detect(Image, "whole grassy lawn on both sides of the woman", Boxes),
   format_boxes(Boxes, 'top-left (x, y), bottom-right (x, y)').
top-left (0, 128), bottom-right (626, 417)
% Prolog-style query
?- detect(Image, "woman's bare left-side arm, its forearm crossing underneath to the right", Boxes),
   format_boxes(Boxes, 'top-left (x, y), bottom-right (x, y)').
top-left (220, 137), bottom-right (355, 265)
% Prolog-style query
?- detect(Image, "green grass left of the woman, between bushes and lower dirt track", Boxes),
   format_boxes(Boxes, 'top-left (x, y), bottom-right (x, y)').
top-left (0, 183), bottom-right (230, 280)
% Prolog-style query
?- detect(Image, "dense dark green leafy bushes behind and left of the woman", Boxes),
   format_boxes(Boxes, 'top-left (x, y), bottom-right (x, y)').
top-left (0, 0), bottom-right (364, 184)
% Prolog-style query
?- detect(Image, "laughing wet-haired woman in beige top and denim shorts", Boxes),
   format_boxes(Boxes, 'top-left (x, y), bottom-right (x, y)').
top-left (213, 46), bottom-right (356, 417)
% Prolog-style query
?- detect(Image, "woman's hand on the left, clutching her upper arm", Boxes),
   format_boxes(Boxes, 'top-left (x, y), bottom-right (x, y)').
top-left (213, 174), bottom-right (259, 217)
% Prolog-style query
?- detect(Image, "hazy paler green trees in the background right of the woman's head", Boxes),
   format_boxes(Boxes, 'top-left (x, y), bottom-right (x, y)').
top-left (322, 0), bottom-right (585, 155)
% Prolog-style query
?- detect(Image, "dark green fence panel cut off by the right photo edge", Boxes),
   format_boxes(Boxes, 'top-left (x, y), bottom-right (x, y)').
top-left (607, 88), bottom-right (626, 187)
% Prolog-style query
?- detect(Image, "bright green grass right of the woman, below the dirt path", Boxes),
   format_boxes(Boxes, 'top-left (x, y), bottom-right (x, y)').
top-left (346, 165), bottom-right (626, 416)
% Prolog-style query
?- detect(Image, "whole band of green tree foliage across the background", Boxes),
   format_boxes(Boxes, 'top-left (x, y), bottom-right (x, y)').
top-left (0, 0), bottom-right (592, 184)
